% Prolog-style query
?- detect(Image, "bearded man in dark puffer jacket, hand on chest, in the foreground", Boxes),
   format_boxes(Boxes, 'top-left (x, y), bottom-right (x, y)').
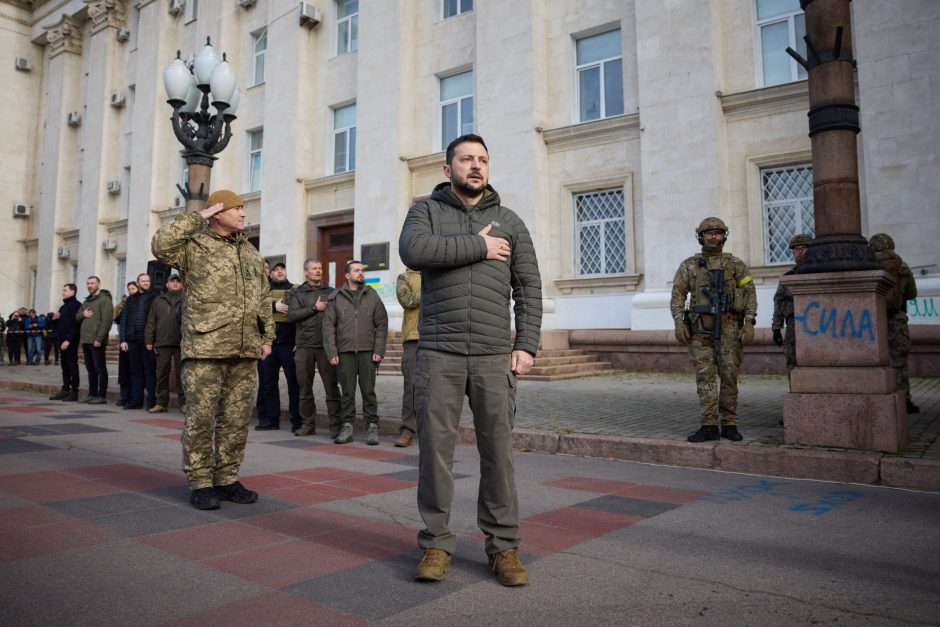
top-left (398, 135), bottom-right (542, 586)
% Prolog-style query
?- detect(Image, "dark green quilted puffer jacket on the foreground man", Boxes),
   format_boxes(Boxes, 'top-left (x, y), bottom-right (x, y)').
top-left (398, 183), bottom-right (542, 355)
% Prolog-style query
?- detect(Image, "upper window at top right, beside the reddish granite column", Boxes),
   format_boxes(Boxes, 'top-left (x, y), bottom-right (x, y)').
top-left (757, 0), bottom-right (806, 87)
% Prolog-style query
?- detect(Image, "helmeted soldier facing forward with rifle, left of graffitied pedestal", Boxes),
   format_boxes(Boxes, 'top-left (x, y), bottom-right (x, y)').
top-left (670, 217), bottom-right (757, 442)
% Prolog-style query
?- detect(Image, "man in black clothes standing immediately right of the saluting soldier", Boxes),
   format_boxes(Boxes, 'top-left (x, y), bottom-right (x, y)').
top-left (255, 263), bottom-right (302, 431)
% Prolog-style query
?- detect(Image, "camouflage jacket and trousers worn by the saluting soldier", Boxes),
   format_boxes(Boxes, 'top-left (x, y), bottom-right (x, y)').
top-left (151, 206), bottom-right (274, 490)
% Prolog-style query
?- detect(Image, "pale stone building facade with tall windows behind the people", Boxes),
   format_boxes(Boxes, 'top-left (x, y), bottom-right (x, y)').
top-left (0, 0), bottom-right (940, 329)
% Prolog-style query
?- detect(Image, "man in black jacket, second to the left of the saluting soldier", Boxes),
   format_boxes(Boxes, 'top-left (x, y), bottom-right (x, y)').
top-left (120, 274), bottom-right (157, 409)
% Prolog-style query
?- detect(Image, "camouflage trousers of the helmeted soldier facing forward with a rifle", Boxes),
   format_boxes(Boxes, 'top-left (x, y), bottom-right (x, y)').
top-left (689, 324), bottom-right (743, 426)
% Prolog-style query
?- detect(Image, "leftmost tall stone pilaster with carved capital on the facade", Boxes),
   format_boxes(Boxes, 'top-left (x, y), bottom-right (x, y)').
top-left (35, 16), bottom-right (84, 309)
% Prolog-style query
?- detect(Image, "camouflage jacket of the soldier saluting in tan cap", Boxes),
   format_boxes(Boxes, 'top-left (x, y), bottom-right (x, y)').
top-left (150, 211), bottom-right (274, 359)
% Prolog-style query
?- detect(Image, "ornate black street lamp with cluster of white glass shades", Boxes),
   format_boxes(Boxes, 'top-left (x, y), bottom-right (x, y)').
top-left (163, 37), bottom-right (239, 211)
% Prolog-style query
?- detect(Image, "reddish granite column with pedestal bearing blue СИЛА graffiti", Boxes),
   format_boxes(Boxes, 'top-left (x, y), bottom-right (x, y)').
top-left (780, 0), bottom-right (907, 453)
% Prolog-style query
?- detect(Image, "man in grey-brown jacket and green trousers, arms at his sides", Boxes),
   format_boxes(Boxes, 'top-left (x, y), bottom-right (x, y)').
top-left (323, 259), bottom-right (388, 446)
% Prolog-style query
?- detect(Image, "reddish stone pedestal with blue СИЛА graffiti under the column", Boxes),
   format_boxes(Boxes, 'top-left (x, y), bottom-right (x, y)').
top-left (780, 270), bottom-right (907, 453)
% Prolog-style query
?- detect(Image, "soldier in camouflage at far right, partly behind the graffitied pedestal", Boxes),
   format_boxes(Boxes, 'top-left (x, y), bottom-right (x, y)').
top-left (869, 233), bottom-right (920, 413)
